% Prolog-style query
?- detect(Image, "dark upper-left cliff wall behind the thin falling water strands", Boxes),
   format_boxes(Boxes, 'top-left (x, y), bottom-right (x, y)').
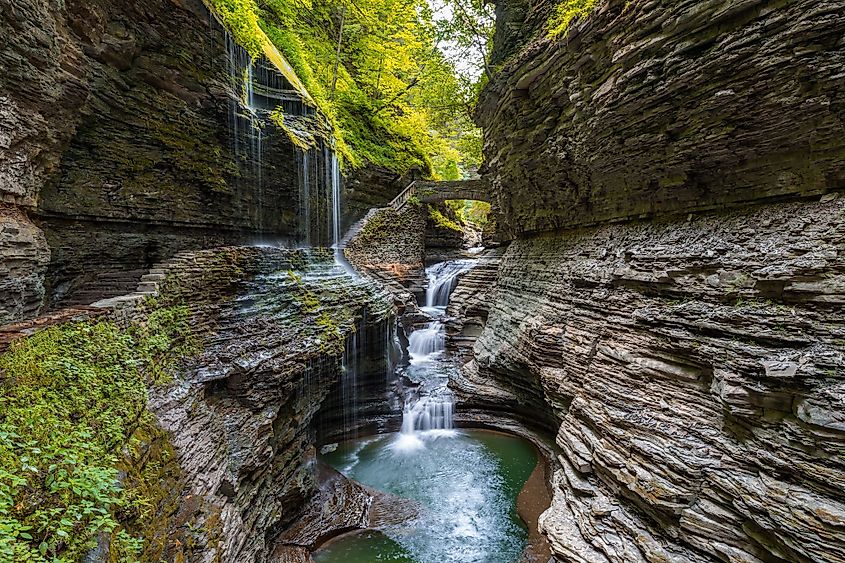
top-left (0, 0), bottom-right (398, 323)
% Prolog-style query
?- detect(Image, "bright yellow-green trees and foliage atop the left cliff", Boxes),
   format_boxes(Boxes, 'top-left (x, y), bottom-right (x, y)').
top-left (207, 0), bottom-right (481, 179)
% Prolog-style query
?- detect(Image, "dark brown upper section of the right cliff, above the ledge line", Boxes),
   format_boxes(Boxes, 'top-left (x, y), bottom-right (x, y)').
top-left (477, 0), bottom-right (845, 233)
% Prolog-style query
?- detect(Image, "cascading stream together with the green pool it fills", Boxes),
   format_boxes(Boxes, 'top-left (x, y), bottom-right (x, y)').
top-left (313, 260), bottom-right (538, 563)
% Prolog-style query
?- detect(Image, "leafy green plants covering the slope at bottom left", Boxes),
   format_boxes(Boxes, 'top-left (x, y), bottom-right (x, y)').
top-left (0, 307), bottom-right (196, 561)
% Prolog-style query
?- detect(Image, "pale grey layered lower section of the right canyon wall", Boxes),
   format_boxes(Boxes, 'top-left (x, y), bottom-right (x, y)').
top-left (458, 197), bottom-right (845, 562)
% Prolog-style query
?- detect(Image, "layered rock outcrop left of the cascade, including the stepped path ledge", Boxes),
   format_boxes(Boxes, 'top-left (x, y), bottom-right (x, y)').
top-left (0, 247), bottom-right (393, 562)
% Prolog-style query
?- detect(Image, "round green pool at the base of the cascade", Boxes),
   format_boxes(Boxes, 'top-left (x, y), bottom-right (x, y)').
top-left (314, 430), bottom-right (537, 563)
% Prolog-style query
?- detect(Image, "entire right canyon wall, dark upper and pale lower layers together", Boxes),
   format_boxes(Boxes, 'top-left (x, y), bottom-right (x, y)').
top-left (464, 0), bottom-right (845, 563)
